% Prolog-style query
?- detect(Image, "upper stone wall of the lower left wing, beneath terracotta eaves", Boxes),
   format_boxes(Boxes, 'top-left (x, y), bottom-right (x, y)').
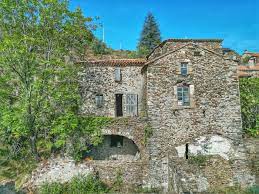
top-left (81, 63), bottom-right (144, 117)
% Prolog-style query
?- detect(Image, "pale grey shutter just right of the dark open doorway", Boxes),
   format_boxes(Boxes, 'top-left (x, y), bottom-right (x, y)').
top-left (125, 94), bottom-right (138, 116)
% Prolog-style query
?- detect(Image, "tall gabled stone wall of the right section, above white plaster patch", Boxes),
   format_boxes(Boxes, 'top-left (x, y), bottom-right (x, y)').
top-left (146, 42), bottom-right (253, 189)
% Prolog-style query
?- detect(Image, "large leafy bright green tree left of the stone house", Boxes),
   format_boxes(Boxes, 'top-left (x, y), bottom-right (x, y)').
top-left (0, 0), bottom-right (95, 160)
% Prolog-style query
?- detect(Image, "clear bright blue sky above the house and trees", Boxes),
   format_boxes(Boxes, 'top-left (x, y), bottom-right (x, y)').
top-left (70, 0), bottom-right (259, 53)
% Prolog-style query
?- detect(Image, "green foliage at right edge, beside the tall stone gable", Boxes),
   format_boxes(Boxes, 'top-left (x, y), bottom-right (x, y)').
top-left (239, 78), bottom-right (259, 136)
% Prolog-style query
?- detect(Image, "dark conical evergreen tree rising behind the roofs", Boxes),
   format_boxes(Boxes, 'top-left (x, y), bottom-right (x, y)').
top-left (138, 13), bottom-right (161, 55)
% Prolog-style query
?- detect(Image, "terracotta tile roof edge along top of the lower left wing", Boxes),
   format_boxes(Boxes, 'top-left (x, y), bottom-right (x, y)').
top-left (78, 59), bottom-right (146, 66)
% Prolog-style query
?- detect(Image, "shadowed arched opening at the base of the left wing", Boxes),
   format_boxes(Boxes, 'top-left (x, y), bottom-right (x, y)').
top-left (90, 135), bottom-right (140, 160)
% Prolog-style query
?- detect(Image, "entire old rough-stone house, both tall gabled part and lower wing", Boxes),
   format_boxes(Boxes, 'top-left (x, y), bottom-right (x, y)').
top-left (27, 39), bottom-right (255, 193)
